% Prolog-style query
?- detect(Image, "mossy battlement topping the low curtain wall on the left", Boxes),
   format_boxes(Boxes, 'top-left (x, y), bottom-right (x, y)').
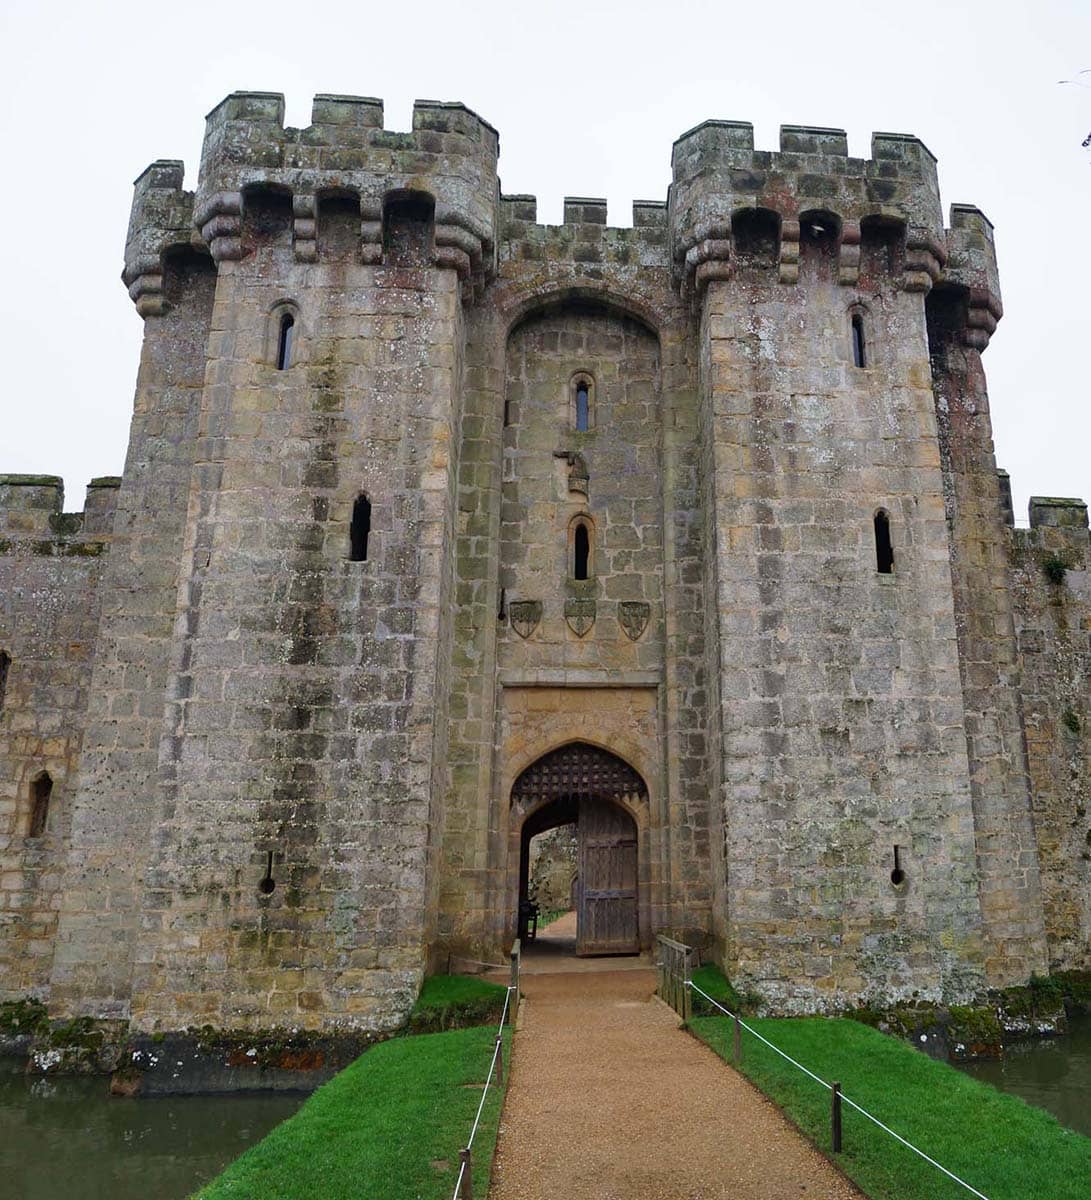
top-left (0, 475), bottom-right (121, 557)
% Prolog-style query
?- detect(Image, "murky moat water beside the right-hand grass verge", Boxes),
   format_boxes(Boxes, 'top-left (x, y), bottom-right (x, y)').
top-left (959, 1016), bottom-right (1091, 1136)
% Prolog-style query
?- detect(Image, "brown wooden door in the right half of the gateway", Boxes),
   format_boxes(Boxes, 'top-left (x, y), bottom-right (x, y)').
top-left (576, 798), bottom-right (640, 955)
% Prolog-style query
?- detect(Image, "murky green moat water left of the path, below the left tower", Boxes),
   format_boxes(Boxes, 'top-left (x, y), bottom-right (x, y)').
top-left (0, 1058), bottom-right (305, 1200)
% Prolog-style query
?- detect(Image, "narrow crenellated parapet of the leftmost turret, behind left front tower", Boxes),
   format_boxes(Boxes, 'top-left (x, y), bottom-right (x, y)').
top-left (121, 158), bottom-right (197, 317)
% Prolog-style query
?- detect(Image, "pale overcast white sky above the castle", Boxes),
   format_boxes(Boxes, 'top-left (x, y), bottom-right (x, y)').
top-left (0, 0), bottom-right (1091, 522)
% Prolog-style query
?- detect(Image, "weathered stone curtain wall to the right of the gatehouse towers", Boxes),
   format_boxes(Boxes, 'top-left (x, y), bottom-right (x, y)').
top-left (1009, 497), bottom-right (1091, 971)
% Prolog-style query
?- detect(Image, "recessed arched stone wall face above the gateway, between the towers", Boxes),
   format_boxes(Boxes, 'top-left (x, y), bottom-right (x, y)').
top-left (498, 310), bottom-right (663, 677)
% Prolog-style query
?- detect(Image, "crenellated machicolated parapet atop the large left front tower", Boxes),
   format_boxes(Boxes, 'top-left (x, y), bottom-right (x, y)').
top-left (188, 92), bottom-right (499, 282)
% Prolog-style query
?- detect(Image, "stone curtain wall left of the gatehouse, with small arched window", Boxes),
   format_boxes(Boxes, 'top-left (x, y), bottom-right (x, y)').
top-left (0, 475), bottom-right (118, 1000)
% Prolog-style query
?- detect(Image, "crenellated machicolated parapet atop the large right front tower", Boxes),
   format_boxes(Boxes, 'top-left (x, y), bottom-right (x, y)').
top-left (670, 121), bottom-right (947, 292)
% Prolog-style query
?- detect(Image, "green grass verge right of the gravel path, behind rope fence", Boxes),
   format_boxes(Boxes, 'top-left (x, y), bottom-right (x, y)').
top-left (690, 1012), bottom-right (1091, 1200)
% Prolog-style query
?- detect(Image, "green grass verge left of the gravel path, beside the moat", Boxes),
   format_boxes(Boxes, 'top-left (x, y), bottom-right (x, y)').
top-left (194, 1028), bottom-right (511, 1200)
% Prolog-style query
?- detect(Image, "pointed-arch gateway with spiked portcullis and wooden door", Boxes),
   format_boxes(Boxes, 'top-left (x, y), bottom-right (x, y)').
top-left (511, 742), bottom-right (648, 955)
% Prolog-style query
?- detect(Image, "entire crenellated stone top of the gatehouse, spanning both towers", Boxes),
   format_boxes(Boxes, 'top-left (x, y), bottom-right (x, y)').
top-left (125, 91), bottom-right (1001, 321)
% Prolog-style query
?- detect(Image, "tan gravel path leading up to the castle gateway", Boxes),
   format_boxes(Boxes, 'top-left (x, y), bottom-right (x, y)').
top-left (488, 971), bottom-right (861, 1200)
